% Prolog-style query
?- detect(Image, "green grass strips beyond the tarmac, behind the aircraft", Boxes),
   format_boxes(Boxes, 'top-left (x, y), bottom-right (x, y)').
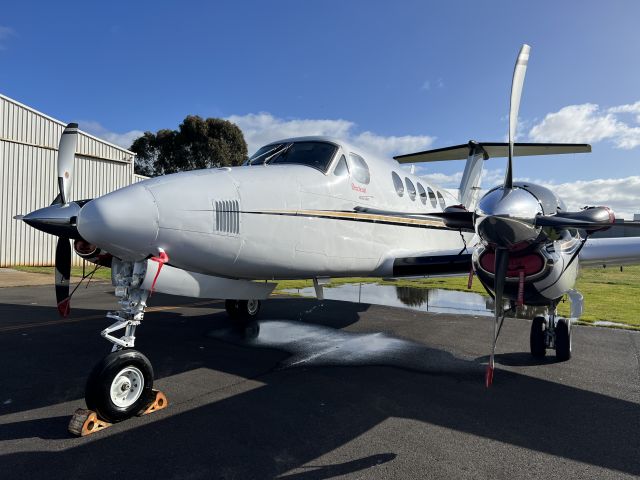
top-left (13, 266), bottom-right (640, 329)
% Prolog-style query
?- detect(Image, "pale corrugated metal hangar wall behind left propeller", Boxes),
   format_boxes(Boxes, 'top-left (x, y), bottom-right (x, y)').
top-left (0, 95), bottom-right (140, 267)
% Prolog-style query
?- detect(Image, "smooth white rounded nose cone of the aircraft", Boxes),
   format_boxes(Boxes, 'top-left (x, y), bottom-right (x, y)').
top-left (77, 185), bottom-right (159, 260)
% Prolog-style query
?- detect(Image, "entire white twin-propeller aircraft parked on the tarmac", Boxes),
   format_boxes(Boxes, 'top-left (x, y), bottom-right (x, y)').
top-left (19, 45), bottom-right (640, 422)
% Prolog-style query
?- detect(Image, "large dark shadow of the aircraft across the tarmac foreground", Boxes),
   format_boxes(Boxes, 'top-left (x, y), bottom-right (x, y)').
top-left (0, 296), bottom-right (640, 479)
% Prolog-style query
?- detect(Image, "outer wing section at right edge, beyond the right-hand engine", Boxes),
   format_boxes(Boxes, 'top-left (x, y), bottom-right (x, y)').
top-left (579, 237), bottom-right (640, 267)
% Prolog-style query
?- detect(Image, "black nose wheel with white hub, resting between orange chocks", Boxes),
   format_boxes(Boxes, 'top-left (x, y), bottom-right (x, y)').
top-left (85, 349), bottom-right (153, 423)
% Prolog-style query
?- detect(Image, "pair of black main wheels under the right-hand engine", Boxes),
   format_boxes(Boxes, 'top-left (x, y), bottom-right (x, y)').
top-left (529, 315), bottom-right (571, 361)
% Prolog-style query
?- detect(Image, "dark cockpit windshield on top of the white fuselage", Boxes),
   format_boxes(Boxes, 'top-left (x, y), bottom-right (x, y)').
top-left (247, 142), bottom-right (338, 173)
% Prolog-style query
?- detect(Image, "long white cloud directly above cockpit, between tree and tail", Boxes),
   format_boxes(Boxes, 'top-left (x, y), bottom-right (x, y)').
top-left (227, 112), bottom-right (435, 157)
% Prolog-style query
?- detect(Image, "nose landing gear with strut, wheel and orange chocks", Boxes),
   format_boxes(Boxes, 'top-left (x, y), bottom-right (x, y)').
top-left (69, 261), bottom-right (168, 435)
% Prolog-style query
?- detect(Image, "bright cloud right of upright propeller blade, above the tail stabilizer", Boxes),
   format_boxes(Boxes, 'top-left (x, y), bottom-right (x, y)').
top-left (529, 102), bottom-right (640, 150)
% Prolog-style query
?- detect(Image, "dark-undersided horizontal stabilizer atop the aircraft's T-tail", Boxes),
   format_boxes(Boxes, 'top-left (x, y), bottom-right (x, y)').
top-left (393, 142), bottom-right (591, 163)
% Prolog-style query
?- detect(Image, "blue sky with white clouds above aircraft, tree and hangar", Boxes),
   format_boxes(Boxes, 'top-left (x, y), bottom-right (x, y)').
top-left (0, 0), bottom-right (640, 213)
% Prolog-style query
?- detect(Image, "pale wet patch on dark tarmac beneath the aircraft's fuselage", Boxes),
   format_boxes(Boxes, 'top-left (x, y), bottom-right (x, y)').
top-left (207, 320), bottom-right (482, 378)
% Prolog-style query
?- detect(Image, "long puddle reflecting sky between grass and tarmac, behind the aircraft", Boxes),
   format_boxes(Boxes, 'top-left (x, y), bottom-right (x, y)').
top-left (283, 283), bottom-right (493, 316)
